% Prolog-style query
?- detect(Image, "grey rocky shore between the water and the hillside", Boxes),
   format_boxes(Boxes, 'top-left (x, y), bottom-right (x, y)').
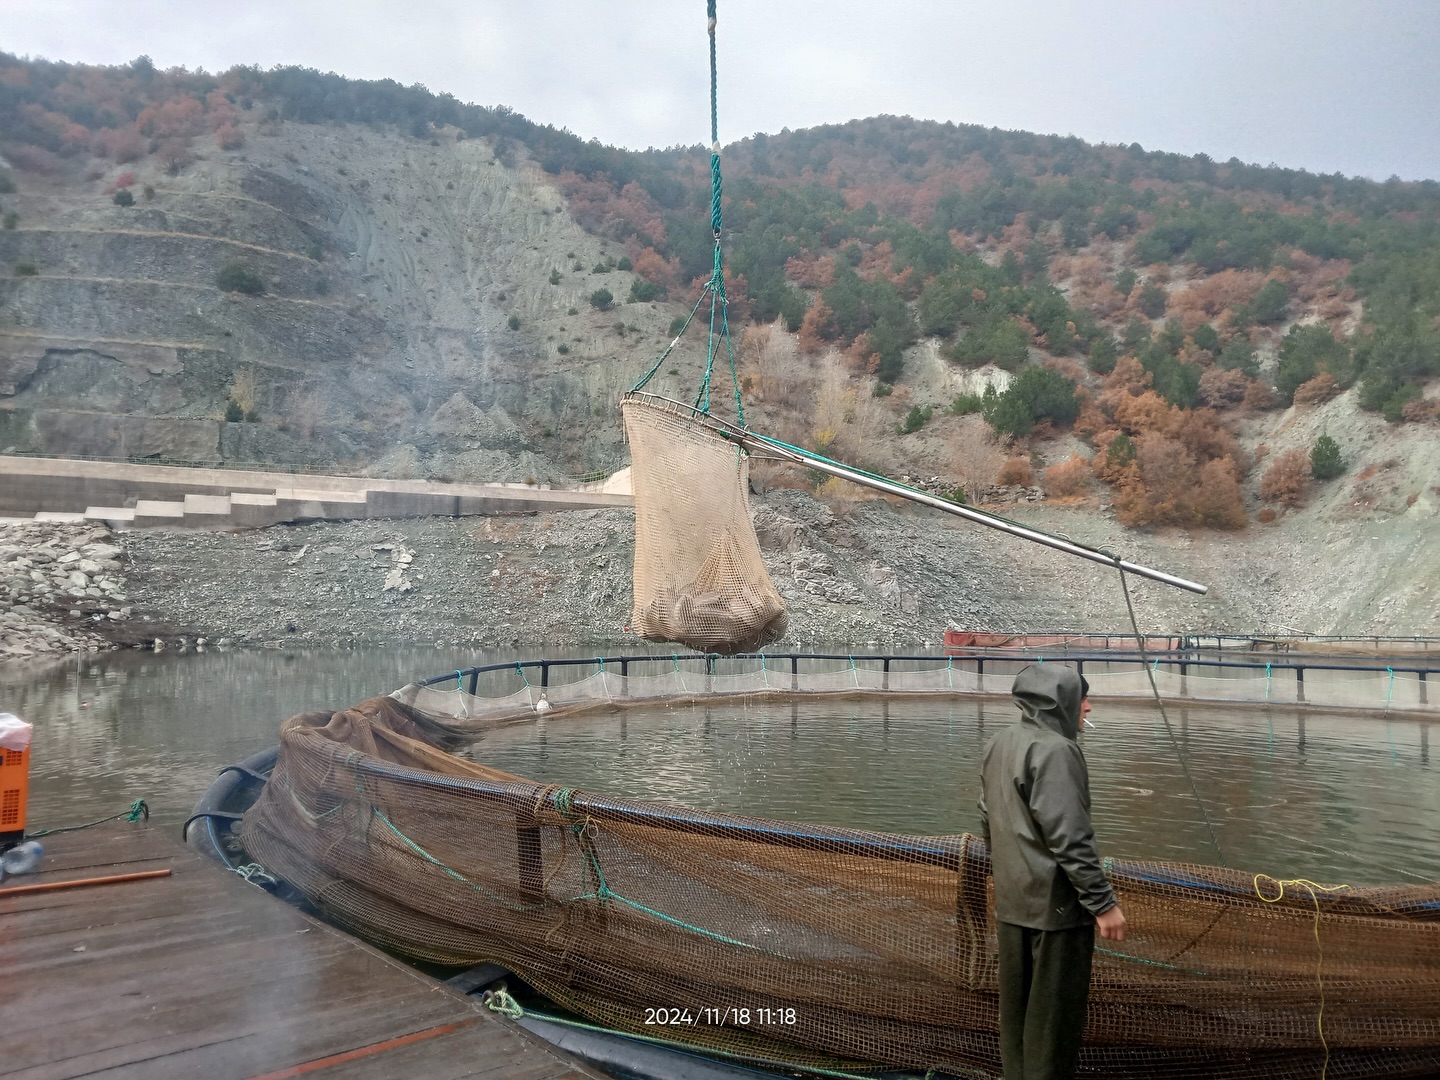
top-left (0, 490), bottom-right (1437, 661)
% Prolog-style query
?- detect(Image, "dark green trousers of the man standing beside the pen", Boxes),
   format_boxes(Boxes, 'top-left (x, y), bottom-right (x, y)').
top-left (999, 923), bottom-right (1094, 1080)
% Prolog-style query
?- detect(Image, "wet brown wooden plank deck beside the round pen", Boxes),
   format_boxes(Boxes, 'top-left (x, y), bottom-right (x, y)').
top-left (0, 822), bottom-right (600, 1080)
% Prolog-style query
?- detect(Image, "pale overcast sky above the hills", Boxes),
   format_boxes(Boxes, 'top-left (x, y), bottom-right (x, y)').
top-left (11, 0), bottom-right (1440, 180)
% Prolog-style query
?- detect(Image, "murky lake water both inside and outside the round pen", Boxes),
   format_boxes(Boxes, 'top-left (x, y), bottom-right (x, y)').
top-left (0, 648), bottom-right (1440, 884)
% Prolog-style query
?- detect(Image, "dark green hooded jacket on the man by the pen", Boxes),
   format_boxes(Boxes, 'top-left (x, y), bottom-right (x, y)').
top-left (979, 664), bottom-right (1116, 930)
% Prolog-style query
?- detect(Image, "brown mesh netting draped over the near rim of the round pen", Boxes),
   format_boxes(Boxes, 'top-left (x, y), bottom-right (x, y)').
top-left (240, 685), bottom-right (1440, 1080)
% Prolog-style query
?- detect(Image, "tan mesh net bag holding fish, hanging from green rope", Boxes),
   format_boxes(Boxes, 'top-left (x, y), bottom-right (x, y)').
top-left (621, 395), bottom-right (788, 652)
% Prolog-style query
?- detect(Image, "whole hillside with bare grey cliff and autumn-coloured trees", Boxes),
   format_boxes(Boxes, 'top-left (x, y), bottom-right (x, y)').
top-left (0, 55), bottom-right (1440, 631)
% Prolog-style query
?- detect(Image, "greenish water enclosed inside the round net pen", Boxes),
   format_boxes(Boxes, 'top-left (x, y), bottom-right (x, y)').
top-left (471, 698), bottom-right (1440, 884)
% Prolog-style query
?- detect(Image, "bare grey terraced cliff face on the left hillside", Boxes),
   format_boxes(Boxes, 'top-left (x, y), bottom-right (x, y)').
top-left (0, 122), bottom-right (703, 480)
